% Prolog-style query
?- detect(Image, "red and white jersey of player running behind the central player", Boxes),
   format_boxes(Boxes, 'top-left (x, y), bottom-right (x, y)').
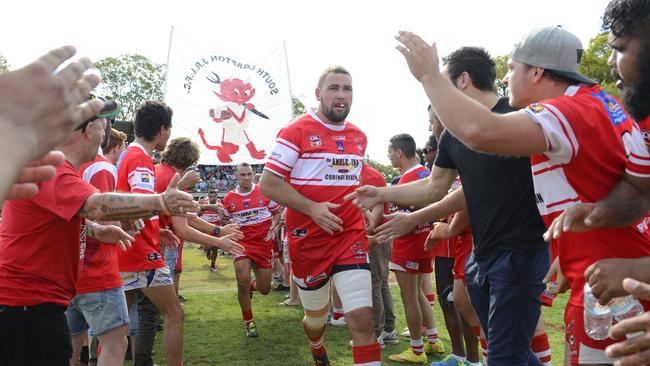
top-left (223, 184), bottom-right (280, 245)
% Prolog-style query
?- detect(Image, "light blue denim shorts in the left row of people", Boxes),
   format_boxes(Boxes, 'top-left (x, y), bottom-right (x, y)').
top-left (65, 286), bottom-right (129, 336)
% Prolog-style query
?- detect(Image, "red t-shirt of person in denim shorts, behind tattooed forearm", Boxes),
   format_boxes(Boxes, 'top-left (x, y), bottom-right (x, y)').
top-left (77, 155), bottom-right (122, 294)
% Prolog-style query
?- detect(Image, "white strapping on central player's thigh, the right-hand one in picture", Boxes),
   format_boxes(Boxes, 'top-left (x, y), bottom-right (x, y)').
top-left (332, 269), bottom-right (372, 313)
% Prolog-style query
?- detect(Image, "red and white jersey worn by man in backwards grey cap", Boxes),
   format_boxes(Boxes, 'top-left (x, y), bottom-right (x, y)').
top-left (525, 86), bottom-right (650, 306)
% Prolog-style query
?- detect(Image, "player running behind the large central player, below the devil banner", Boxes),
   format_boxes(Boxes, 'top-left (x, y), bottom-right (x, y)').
top-left (223, 163), bottom-right (280, 337)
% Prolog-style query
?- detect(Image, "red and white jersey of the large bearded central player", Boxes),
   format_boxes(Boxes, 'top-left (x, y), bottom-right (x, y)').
top-left (264, 110), bottom-right (367, 242)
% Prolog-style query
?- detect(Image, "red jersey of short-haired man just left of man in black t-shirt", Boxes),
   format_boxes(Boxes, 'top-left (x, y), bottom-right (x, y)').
top-left (392, 164), bottom-right (434, 259)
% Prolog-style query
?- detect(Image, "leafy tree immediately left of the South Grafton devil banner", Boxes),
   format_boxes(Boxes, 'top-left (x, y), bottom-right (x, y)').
top-left (95, 54), bottom-right (165, 120)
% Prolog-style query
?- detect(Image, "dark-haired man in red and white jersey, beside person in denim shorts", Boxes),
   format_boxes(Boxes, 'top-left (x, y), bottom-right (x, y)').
top-left (117, 101), bottom-right (183, 366)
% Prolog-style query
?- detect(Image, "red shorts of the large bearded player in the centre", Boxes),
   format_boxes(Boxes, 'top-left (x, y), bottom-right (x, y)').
top-left (289, 230), bottom-right (370, 288)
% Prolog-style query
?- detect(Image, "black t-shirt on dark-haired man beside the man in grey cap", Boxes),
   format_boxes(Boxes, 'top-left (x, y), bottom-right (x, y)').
top-left (435, 98), bottom-right (546, 259)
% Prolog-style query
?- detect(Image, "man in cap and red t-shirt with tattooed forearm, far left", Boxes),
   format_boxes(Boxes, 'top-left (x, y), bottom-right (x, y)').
top-left (0, 98), bottom-right (197, 366)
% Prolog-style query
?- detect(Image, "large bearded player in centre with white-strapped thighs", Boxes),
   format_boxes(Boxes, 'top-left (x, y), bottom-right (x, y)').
top-left (261, 67), bottom-right (381, 366)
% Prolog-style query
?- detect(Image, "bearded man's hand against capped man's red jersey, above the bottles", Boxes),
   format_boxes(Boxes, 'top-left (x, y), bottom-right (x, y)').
top-left (544, 203), bottom-right (607, 241)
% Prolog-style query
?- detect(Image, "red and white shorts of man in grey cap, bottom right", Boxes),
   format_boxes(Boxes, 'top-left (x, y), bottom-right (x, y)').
top-left (564, 303), bottom-right (615, 365)
